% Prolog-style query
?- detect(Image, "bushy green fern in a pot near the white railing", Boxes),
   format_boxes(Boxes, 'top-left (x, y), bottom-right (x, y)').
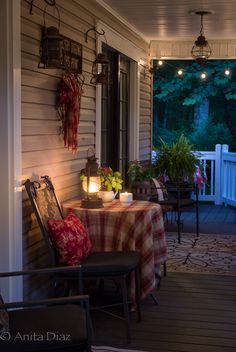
top-left (156, 135), bottom-right (198, 182)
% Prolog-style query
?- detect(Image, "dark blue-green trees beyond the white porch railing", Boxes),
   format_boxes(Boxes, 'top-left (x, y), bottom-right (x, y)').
top-left (153, 60), bottom-right (236, 151)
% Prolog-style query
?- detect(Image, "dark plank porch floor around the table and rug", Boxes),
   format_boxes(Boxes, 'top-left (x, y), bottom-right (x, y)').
top-left (93, 204), bottom-right (236, 352)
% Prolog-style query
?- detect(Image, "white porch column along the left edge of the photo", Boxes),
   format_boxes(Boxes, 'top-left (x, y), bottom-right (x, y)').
top-left (0, 0), bottom-right (22, 300)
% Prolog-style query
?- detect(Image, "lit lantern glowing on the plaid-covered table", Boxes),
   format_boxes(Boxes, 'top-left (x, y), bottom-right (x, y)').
top-left (81, 155), bottom-right (103, 209)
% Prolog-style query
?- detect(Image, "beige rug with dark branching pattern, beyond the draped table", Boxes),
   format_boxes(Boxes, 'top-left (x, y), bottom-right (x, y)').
top-left (166, 233), bottom-right (236, 275)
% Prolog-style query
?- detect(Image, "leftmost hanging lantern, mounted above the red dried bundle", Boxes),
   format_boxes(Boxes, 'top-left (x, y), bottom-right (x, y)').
top-left (38, 4), bottom-right (63, 68)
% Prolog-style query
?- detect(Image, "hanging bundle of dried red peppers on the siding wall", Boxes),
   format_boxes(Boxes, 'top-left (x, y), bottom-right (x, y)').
top-left (57, 72), bottom-right (83, 152)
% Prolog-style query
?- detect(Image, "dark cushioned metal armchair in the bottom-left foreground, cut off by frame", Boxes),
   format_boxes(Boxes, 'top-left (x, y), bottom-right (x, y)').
top-left (0, 266), bottom-right (91, 352)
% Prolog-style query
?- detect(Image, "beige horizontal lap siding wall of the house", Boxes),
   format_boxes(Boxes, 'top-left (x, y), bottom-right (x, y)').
top-left (21, 0), bottom-right (152, 297)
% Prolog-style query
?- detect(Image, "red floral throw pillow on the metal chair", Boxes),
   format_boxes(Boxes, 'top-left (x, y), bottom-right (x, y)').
top-left (48, 211), bottom-right (92, 265)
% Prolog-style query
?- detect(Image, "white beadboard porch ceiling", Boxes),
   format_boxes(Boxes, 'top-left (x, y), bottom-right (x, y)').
top-left (97, 0), bottom-right (236, 41)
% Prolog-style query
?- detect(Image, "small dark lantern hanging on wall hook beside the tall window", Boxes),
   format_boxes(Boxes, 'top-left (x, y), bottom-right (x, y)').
top-left (90, 53), bottom-right (110, 84)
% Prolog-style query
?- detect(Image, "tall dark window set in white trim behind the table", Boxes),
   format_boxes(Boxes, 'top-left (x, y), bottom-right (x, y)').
top-left (101, 48), bottom-right (130, 186)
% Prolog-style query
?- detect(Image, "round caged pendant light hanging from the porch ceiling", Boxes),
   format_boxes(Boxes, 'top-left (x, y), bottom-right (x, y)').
top-left (191, 11), bottom-right (211, 65)
